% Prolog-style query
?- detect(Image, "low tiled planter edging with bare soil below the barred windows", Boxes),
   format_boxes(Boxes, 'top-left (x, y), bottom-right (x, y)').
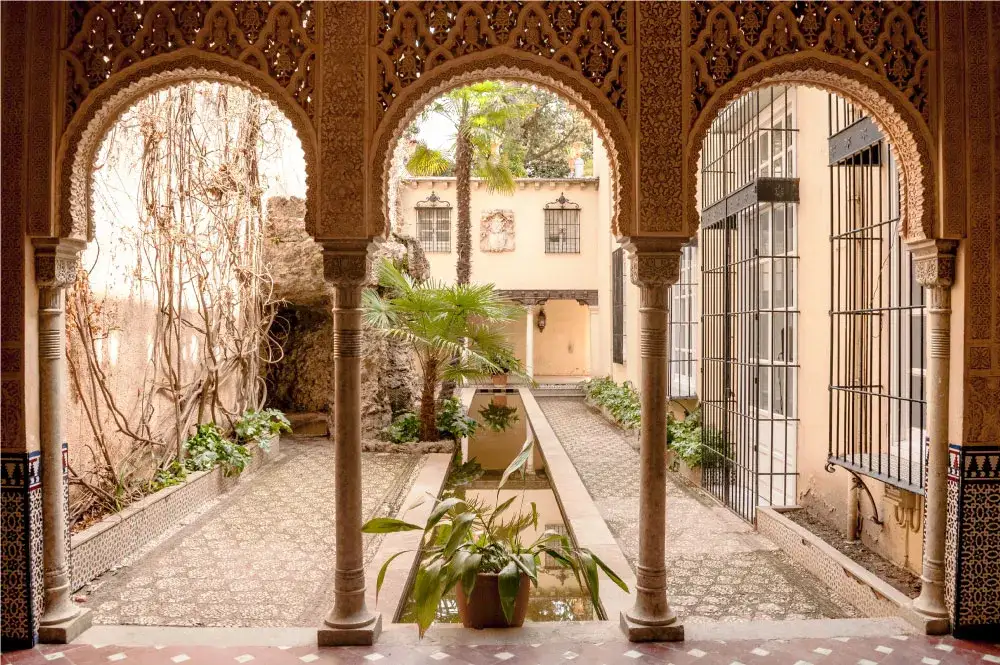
top-left (757, 506), bottom-right (946, 634)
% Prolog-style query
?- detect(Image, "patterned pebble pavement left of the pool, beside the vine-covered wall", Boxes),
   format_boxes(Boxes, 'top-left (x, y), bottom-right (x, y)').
top-left (78, 437), bottom-right (423, 624)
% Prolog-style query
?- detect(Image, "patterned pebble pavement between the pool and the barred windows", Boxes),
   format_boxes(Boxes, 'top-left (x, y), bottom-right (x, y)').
top-left (537, 397), bottom-right (857, 623)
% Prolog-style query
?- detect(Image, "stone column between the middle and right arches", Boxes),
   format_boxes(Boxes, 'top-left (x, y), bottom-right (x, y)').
top-left (621, 241), bottom-right (684, 642)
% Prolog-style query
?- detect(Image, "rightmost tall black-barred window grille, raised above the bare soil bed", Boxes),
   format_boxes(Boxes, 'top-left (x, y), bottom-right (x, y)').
top-left (829, 95), bottom-right (926, 493)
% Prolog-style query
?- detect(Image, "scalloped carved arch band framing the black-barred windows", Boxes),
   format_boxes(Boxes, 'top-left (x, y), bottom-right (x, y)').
top-left (684, 52), bottom-right (937, 241)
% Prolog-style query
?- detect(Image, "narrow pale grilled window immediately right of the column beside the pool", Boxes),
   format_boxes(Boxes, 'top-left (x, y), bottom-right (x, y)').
top-left (670, 241), bottom-right (698, 399)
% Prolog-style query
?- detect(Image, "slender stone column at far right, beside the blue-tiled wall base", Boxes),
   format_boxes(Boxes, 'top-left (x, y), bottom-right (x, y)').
top-left (909, 240), bottom-right (956, 635)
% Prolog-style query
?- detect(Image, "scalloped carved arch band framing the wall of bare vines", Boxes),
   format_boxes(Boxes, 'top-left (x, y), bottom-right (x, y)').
top-left (55, 49), bottom-right (317, 241)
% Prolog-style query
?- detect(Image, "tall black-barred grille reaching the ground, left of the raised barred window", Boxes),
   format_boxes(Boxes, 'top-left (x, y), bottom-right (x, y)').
top-left (699, 87), bottom-right (798, 521)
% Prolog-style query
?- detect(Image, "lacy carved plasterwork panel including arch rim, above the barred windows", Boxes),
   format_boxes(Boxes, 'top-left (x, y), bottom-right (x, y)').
top-left (684, 2), bottom-right (936, 239)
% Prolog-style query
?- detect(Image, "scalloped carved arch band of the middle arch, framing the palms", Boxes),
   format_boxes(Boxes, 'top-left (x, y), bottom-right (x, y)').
top-left (369, 48), bottom-right (635, 237)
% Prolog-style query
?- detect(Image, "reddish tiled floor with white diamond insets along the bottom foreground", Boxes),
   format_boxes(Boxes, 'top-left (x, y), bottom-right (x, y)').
top-left (2, 635), bottom-right (1000, 665)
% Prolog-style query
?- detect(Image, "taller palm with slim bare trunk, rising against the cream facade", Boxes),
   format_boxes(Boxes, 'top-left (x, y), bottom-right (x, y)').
top-left (406, 81), bottom-right (532, 284)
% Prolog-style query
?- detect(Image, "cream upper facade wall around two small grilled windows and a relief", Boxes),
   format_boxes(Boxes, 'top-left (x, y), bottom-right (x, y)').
top-left (400, 176), bottom-right (607, 289)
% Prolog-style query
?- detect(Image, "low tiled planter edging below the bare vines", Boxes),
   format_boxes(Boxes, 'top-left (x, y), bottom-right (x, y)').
top-left (70, 437), bottom-right (280, 591)
